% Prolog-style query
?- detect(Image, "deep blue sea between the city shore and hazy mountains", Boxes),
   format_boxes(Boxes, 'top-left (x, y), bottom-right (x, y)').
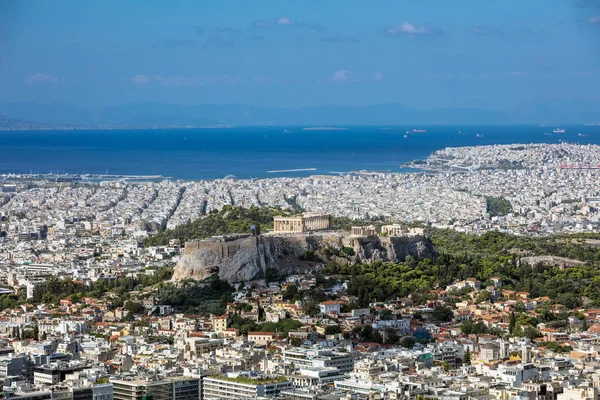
top-left (0, 125), bottom-right (600, 180)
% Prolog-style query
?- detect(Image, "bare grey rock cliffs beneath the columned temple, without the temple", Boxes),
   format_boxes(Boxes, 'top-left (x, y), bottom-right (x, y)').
top-left (173, 234), bottom-right (435, 283)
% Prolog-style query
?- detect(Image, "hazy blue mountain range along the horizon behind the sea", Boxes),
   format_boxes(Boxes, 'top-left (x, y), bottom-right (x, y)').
top-left (0, 101), bottom-right (600, 129)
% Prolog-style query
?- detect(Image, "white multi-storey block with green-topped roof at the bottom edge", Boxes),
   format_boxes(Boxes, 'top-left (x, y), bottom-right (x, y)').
top-left (202, 374), bottom-right (293, 400)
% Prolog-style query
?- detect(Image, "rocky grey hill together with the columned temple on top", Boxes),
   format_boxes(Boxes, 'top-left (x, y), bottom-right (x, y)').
top-left (173, 214), bottom-right (435, 282)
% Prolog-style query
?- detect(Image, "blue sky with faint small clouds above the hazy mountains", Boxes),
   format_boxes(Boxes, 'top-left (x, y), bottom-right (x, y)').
top-left (0, 0), bottom-right (600, 108)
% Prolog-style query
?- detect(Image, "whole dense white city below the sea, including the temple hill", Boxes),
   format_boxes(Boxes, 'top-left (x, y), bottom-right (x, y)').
top-left (0, 143), bottom-right (600, 400)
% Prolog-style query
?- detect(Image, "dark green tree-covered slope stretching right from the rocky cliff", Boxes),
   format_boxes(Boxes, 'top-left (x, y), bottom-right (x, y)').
top-left (324, 229), bottom-right (600, 309)
